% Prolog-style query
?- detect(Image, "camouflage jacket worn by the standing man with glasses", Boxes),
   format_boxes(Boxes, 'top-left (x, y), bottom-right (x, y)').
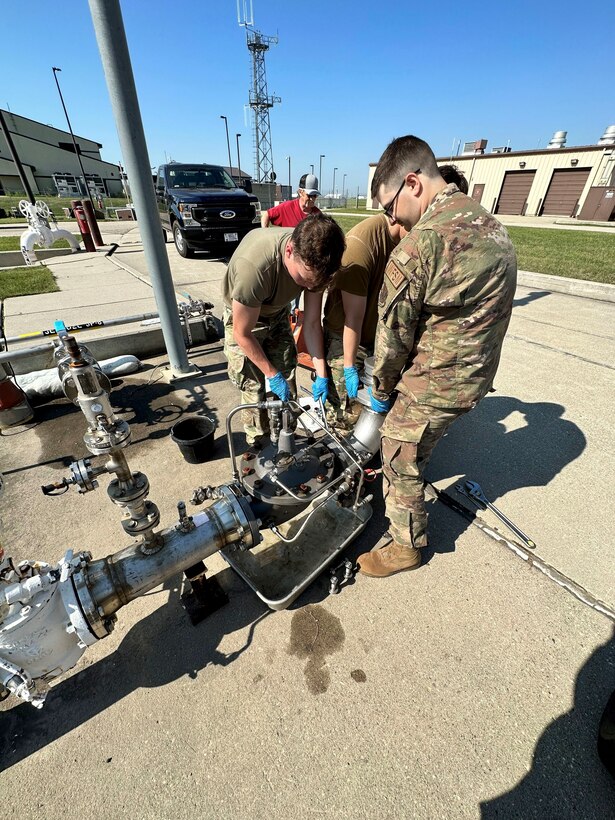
top-left (373, 185), bottom-right (517, 408)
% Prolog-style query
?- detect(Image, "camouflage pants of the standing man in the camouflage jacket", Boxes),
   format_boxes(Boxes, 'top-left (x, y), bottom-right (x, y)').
top-left (380, 395), bottom-right (467, 548)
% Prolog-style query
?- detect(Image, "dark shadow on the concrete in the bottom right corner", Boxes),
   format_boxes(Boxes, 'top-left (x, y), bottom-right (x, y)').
top-left (480, 637), bottom-right (615, 820)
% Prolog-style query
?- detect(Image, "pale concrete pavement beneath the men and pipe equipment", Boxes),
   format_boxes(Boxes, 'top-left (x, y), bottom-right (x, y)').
top-left (0, 221), bottom-right (615, 820)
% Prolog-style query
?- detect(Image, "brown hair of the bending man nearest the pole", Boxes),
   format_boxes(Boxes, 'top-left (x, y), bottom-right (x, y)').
top-left (291, 213), bottom-right (346, 290)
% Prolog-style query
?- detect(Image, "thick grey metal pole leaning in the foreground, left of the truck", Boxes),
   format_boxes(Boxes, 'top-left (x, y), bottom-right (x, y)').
top-left (88, 0), bottom-right (192, 376)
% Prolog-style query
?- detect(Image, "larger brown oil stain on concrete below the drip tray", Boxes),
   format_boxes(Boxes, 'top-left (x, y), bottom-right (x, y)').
top-left (288, 604), bottom-right (346, 695)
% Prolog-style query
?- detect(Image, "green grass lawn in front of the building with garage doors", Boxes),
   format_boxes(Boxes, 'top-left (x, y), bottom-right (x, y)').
top-left (332, 213), bottom-right (615, 285)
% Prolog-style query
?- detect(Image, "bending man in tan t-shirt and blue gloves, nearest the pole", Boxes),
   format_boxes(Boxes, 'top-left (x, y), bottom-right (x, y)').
top-left (223, 214), bottom-right (344, 444)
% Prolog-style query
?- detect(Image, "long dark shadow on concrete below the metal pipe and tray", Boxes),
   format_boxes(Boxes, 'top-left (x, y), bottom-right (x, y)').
top-left (0, 569), bottom-right (269, 771)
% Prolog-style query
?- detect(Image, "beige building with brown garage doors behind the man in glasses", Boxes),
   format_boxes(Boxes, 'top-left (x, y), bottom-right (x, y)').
top-left (368, 126), bottom-right (615, 221)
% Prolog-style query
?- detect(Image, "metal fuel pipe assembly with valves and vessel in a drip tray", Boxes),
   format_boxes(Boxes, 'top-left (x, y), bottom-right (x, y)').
top-left (0, 336), bottom-right (384, 707)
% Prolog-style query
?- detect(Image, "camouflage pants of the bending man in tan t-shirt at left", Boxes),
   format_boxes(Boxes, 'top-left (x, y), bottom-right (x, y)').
top-left (224, 308), bottom-right (297, 444)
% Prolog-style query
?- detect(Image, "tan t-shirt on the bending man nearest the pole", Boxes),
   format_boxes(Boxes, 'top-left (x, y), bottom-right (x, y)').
top-left (222, 228), bottom-right (303, 319)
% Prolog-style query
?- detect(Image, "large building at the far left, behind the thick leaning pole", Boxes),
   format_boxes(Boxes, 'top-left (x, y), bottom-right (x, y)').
top-left (0, 109), bottom-right (123, 196)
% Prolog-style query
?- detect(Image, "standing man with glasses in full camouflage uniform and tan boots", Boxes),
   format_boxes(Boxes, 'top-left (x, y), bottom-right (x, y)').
top-left (358, 136), bottom-right (517, 577)
